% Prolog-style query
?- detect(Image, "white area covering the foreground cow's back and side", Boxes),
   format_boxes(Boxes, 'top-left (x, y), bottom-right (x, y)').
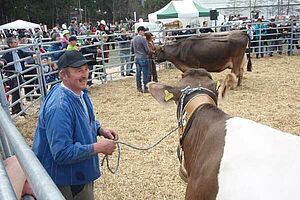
top-left (217, 117), bottom-right (300, 200)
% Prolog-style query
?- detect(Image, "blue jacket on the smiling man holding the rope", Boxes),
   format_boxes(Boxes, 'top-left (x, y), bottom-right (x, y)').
top-left (32, 84), bottom-right (100, 186)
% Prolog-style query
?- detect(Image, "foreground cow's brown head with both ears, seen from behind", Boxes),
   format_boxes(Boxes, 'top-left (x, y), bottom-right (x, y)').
top-left (149, 68), bottom-right (236, 104)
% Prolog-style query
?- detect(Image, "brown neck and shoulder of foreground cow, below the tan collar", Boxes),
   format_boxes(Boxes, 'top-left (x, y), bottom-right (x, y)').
top-left (182, 104), bottom-right (230, 199)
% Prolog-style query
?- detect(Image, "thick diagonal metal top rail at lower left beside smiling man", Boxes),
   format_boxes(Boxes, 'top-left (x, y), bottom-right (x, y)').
top-left (0, 107), bottom-right (65, 200)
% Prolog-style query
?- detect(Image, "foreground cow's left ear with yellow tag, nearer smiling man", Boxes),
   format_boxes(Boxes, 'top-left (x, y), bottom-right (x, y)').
top-left (148, 82), bottom-right (174, 104)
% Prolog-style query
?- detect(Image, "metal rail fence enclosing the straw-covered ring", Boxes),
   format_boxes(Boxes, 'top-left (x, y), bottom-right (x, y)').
top-left (0, 21), bottom-right (300, 199)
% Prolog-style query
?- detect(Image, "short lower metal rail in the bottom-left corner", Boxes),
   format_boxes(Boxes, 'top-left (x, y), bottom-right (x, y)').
top-left (0, 157), bottom-right (17, 200)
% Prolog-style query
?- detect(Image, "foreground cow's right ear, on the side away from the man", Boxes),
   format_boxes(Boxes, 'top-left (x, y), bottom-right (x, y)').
top-left (216, 73), bottom-right (237, 100)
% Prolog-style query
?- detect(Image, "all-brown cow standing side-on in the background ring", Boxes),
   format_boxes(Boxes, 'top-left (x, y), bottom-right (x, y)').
top-left (156, 31), bottom-right (252, 85)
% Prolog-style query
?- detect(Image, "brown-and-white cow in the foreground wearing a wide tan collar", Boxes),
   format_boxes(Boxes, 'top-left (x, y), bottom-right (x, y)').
top-left (149, 69), bottom-right (300, 200)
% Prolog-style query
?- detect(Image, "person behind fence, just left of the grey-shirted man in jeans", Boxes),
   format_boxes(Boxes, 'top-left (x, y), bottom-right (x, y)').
top-left (116, 28), bottom-right (133, 76)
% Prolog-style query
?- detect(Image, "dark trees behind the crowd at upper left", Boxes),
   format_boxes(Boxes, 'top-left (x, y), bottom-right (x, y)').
top-left (0, 0), bottom-right (170, 27)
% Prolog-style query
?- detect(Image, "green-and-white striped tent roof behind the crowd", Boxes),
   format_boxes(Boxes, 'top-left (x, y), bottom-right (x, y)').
top-left (149, 0), bottom-right (209, 20)
